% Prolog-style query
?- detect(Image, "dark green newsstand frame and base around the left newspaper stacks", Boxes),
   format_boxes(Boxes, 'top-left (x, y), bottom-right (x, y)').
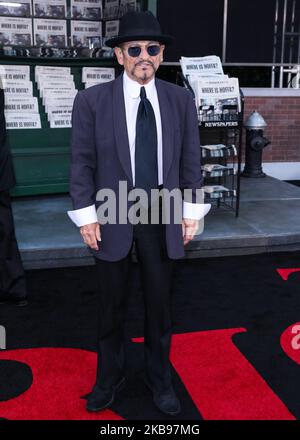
top-left (0, 58), bottom-right (119, 196)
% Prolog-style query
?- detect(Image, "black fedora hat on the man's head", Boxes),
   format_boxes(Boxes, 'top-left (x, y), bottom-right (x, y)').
top-left (105, 11), bottom-right (173, 47)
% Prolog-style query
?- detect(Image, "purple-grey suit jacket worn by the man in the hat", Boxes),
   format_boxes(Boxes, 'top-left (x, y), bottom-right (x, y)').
top-left (70, 75), bottom-right (203, 261)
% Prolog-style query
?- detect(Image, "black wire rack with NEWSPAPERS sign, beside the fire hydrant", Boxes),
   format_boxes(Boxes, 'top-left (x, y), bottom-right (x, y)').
top-left (178, 72), bottom-right (244, 217)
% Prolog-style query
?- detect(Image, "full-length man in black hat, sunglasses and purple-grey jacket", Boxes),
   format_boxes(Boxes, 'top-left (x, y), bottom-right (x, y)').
top-left (69, 12), bottom-right (207, 415)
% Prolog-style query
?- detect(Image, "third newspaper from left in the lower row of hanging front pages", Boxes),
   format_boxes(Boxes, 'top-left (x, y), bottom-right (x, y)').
top-left (71, 20), bottom-right (102, 47)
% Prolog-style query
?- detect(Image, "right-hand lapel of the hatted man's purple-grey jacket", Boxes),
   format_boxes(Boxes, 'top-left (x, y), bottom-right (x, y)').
top-left (155, 79), bottom-right (174, 183)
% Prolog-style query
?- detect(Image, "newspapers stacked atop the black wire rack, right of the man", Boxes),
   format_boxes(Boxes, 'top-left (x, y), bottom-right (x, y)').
top-left (180, 55), bottom-right (241, 121)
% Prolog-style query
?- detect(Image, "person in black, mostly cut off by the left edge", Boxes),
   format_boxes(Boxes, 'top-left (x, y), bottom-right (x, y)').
top-left (0, 88), bottom-right (27, 306)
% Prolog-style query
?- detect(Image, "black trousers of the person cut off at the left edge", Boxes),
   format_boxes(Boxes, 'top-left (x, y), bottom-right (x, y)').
top-left (0, 191), bottom-right (27, 299)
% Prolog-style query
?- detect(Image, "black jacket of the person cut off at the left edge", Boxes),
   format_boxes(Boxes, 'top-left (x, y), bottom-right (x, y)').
top-left (0, 89), bottom-right (16, 191)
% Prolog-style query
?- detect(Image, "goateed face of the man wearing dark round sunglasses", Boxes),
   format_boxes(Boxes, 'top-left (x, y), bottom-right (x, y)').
top-left (115, 41), bottom-right (165, 84)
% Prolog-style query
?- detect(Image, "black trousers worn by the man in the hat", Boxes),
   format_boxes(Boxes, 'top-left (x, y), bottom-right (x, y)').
top-left (96, 198), bottom-right (174, 391)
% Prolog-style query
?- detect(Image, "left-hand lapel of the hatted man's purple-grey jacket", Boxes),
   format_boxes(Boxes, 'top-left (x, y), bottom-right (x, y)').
top-left (113, 75), bottom-right (133, 187)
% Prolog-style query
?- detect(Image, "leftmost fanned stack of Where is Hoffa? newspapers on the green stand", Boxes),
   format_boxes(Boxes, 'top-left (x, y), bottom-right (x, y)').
top-left (0, 64), bottom-right (41, 129)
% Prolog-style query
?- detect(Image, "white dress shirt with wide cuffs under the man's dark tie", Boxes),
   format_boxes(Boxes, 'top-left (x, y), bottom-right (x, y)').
top-left (68, 71), bottom-right (211, 227)
